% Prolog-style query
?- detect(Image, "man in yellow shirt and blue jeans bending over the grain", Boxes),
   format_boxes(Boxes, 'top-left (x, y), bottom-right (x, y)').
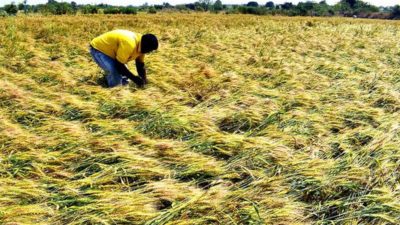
top-left (90, 30), bottom-right (158, 87)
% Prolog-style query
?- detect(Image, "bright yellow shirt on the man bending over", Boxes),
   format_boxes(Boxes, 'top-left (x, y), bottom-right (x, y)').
top-left (90, 30), bottom-right (144, 64)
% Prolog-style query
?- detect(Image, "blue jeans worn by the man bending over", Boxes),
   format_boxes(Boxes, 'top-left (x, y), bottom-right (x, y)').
top-left (90, 46), bottom-right (128, 87)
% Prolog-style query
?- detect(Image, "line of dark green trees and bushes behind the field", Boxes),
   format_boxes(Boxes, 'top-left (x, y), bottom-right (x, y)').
top-left (0, 0), bottom-right (400, 19)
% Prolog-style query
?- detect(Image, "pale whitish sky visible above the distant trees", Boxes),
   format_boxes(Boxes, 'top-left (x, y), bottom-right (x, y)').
top-left (0, 0), bottom-right (400, 6)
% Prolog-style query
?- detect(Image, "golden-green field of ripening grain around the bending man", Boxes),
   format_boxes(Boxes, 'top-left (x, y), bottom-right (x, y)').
top-left (0, 13), bottom-right (400, 225)
